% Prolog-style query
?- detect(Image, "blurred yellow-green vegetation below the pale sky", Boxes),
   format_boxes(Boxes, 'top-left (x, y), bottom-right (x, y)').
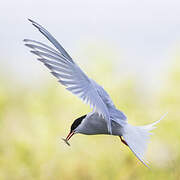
top-left (0, 54), bottom-right (180, 180)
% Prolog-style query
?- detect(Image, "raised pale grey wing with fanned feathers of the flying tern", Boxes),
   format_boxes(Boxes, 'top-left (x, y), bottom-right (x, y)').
top-left (24, 20), bottom-right (112, 134)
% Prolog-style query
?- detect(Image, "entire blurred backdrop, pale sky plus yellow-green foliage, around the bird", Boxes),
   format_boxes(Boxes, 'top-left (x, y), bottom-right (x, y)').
top-left (0, 0), bottom-right (180, 180)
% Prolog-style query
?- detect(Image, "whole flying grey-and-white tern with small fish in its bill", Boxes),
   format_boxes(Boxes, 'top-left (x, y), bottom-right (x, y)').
top-left (24, 19), bottom-right (166, 167)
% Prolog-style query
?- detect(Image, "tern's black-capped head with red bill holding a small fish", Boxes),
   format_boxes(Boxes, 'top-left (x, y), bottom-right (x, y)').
top-left (64, 115), bottom-right (86, 145)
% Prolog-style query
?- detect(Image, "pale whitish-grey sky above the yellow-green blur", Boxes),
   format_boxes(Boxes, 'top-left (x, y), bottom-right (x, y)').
top-left (0, 0), bottom-right (180, 93)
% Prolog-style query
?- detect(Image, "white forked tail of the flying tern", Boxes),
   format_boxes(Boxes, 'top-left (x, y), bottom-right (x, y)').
top-left (123, 113), bottom-right (167, 167)
